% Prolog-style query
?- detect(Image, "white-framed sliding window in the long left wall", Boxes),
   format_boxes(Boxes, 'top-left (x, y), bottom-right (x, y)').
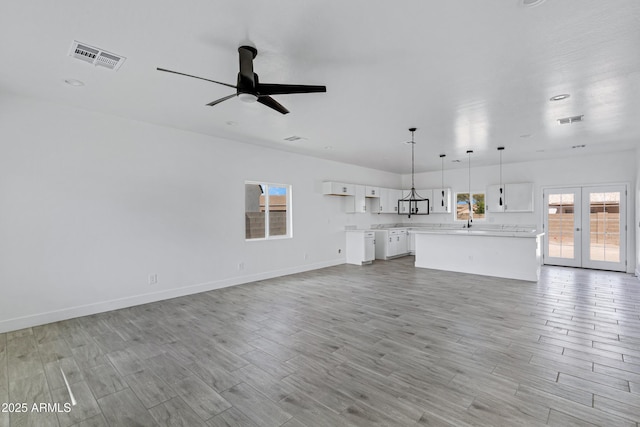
top-left (244, 181), bottom-right (292, 240)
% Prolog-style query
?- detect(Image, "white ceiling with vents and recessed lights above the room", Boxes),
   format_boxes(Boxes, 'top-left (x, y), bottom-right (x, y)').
top-left (0, 0), bottom-right (640, 173)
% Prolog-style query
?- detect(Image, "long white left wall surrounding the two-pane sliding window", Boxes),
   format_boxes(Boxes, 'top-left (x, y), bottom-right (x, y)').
top-left (0, 95), bottom-right (400, 332)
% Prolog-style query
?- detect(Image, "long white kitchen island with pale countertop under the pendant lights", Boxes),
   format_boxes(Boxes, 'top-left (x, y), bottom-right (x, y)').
top-left (411, 228), bottom-right (544, 282)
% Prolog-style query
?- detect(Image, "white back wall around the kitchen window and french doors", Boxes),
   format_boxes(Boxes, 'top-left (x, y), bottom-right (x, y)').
top-left (403, 150), bottom-right (640, 272)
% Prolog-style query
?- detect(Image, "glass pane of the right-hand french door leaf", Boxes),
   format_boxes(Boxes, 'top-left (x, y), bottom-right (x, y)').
top-left (589, 191), bottom-right (620, 262)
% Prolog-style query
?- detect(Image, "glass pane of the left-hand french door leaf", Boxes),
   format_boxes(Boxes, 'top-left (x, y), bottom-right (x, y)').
top-left (548, 193), bottom-right (575, 259)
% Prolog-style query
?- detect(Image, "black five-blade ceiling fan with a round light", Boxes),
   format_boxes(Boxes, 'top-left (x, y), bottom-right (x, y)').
top-left (157, 46), bottom-right (327, 114)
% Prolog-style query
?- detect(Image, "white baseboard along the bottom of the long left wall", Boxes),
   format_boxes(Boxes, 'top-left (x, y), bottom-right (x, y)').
top-left (0, 258), bottom-right (344, 333)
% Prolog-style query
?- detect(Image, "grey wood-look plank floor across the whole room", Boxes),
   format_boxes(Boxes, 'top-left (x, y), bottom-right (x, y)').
top-left (0, 257), bottom-right (640, 427)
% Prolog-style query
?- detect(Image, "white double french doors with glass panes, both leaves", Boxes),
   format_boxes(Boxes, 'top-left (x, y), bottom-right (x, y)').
top-left (544, 185), bottom-right (627, 271)
